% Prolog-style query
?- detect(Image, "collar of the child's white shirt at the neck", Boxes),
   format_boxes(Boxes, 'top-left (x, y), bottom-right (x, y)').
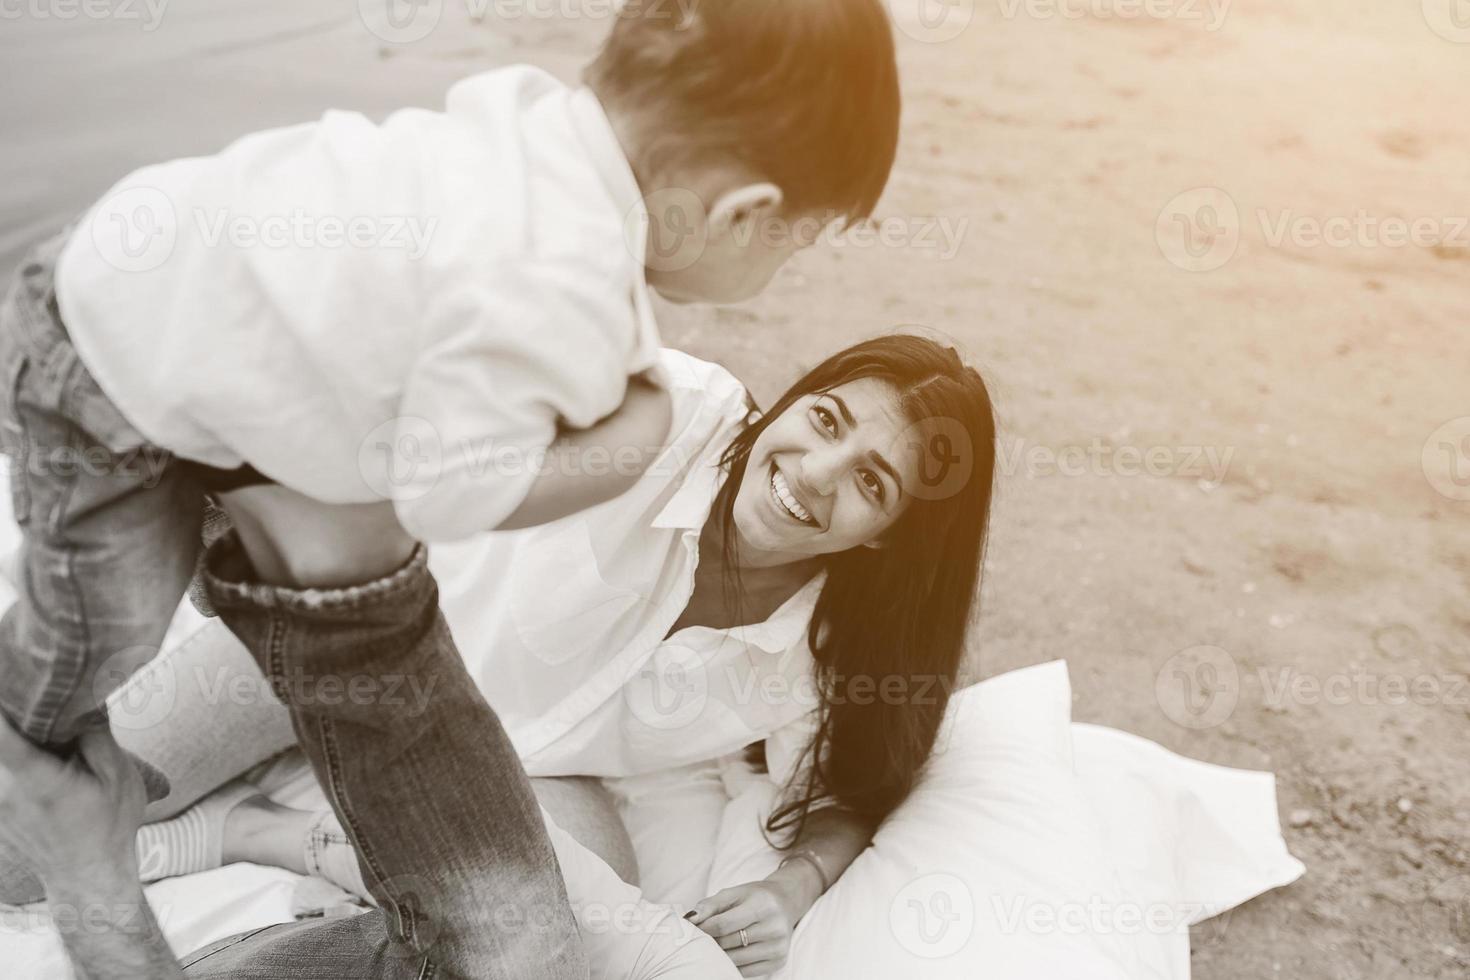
top-left (567, 87), bottom-right (663, 373)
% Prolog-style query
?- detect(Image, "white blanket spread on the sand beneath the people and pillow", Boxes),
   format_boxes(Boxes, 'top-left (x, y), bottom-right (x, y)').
top-left (0, 704), bottom-right (1304, 980)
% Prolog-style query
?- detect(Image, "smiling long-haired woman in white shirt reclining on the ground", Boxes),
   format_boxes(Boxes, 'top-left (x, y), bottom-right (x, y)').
top-left (88, 335), bottom-right (995, 976)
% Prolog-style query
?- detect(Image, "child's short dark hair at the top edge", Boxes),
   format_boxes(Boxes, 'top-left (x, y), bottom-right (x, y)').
top-left (587, 0), bottom-right (900, 222)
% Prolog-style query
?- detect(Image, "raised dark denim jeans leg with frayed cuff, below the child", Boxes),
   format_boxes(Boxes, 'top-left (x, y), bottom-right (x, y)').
top-left (204, 532), bottom-right (587, 980)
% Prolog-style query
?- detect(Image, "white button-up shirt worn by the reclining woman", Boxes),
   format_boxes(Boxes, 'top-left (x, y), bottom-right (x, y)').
top-left (429, 350), bottom-right (822, 783)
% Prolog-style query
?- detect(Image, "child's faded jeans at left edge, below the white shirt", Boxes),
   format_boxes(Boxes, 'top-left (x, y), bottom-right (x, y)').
top-left (0, 226), bottom-right (204, 758)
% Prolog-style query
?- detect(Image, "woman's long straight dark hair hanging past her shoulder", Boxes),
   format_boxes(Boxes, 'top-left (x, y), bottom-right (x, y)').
top-left (714, 334), bottom-right (995, 846)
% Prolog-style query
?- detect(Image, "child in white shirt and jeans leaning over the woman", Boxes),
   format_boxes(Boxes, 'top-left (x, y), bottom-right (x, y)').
top-left (0, 0), bottom-right (898, 975)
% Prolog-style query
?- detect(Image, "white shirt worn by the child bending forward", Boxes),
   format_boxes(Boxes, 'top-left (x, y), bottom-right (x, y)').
top-left (56, 68), bottom-right (660, 541)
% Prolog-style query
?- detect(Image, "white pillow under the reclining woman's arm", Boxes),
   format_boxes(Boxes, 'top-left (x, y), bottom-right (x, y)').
top-left (709, 661), bottom-right (1166, 980)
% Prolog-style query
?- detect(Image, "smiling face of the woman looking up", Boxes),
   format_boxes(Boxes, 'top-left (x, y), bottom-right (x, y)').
top-left (735, 378), bottom-right (919, 564)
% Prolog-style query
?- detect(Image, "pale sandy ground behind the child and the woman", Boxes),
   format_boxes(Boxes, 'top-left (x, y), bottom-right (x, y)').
top-left (0, 0), bottom-right (1470, 980)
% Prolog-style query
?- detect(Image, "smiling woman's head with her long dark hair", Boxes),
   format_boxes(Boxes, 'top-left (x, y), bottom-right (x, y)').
top-left (716, 335), bottom-right (995, 839)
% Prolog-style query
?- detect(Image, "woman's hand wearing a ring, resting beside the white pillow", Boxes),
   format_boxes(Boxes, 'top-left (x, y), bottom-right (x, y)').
top-left (688, 865), bottom-right (822, 977)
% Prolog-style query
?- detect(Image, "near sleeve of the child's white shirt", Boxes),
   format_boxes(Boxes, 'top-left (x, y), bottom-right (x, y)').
top-left (390, 262), bottom-right (637, 542)
